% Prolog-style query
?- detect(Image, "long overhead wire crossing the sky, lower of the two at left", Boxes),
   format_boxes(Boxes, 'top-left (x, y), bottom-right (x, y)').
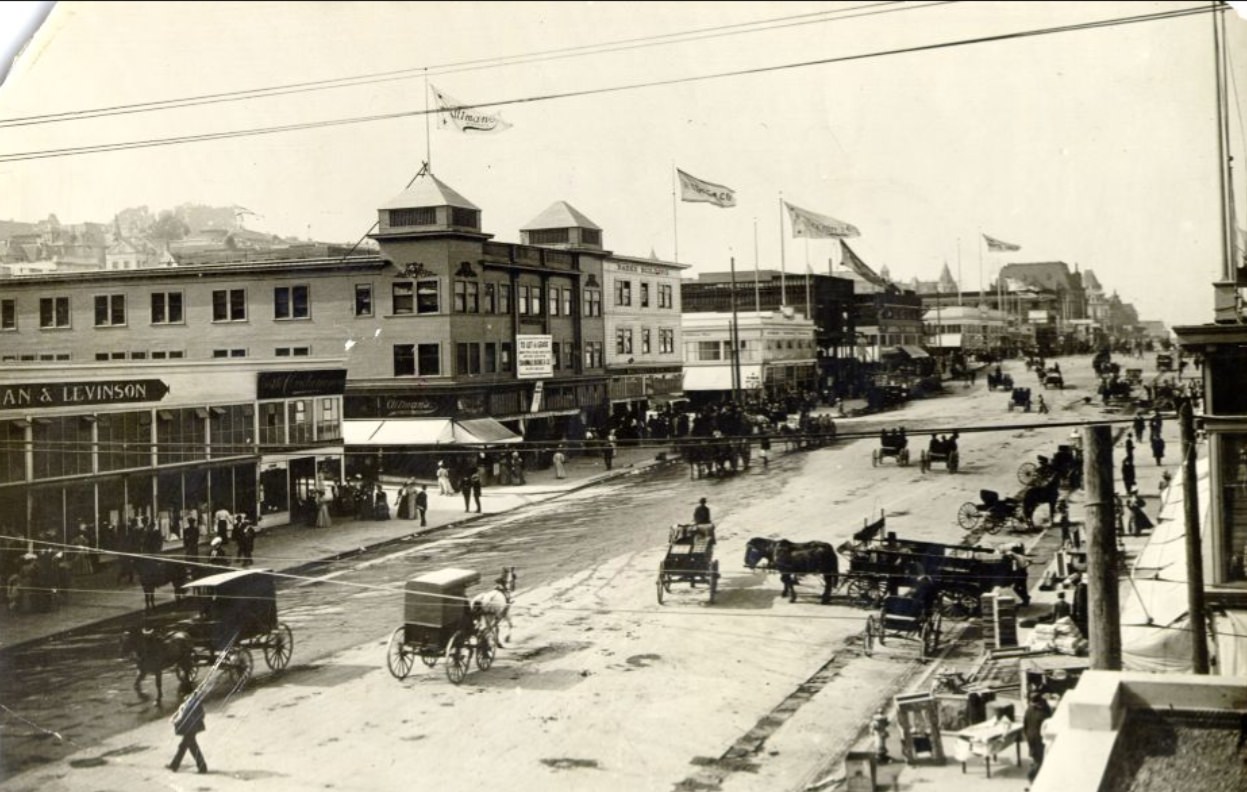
top-left (0, 6), bottom-right (1216, 162)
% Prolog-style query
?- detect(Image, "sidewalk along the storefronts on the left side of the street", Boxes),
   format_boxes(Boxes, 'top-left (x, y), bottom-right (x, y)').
top-left (0, 444), bottom-right (675, 651)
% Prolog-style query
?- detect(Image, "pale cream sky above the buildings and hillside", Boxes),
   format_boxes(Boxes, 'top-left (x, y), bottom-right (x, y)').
top-left (0, 0), bottom-right (1247, 326)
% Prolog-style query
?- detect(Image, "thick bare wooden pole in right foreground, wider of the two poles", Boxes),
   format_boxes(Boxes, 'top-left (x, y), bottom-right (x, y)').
top-left (1082, 424), bottom-right (1121, 671)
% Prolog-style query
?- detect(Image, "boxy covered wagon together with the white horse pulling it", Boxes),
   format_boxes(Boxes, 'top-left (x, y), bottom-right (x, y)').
top-left (385, 567), bottom-right (515, 685)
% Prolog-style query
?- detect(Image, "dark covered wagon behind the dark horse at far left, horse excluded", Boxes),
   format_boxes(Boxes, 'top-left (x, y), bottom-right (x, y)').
top-left (176, 569), bottom-right (294, 683)
